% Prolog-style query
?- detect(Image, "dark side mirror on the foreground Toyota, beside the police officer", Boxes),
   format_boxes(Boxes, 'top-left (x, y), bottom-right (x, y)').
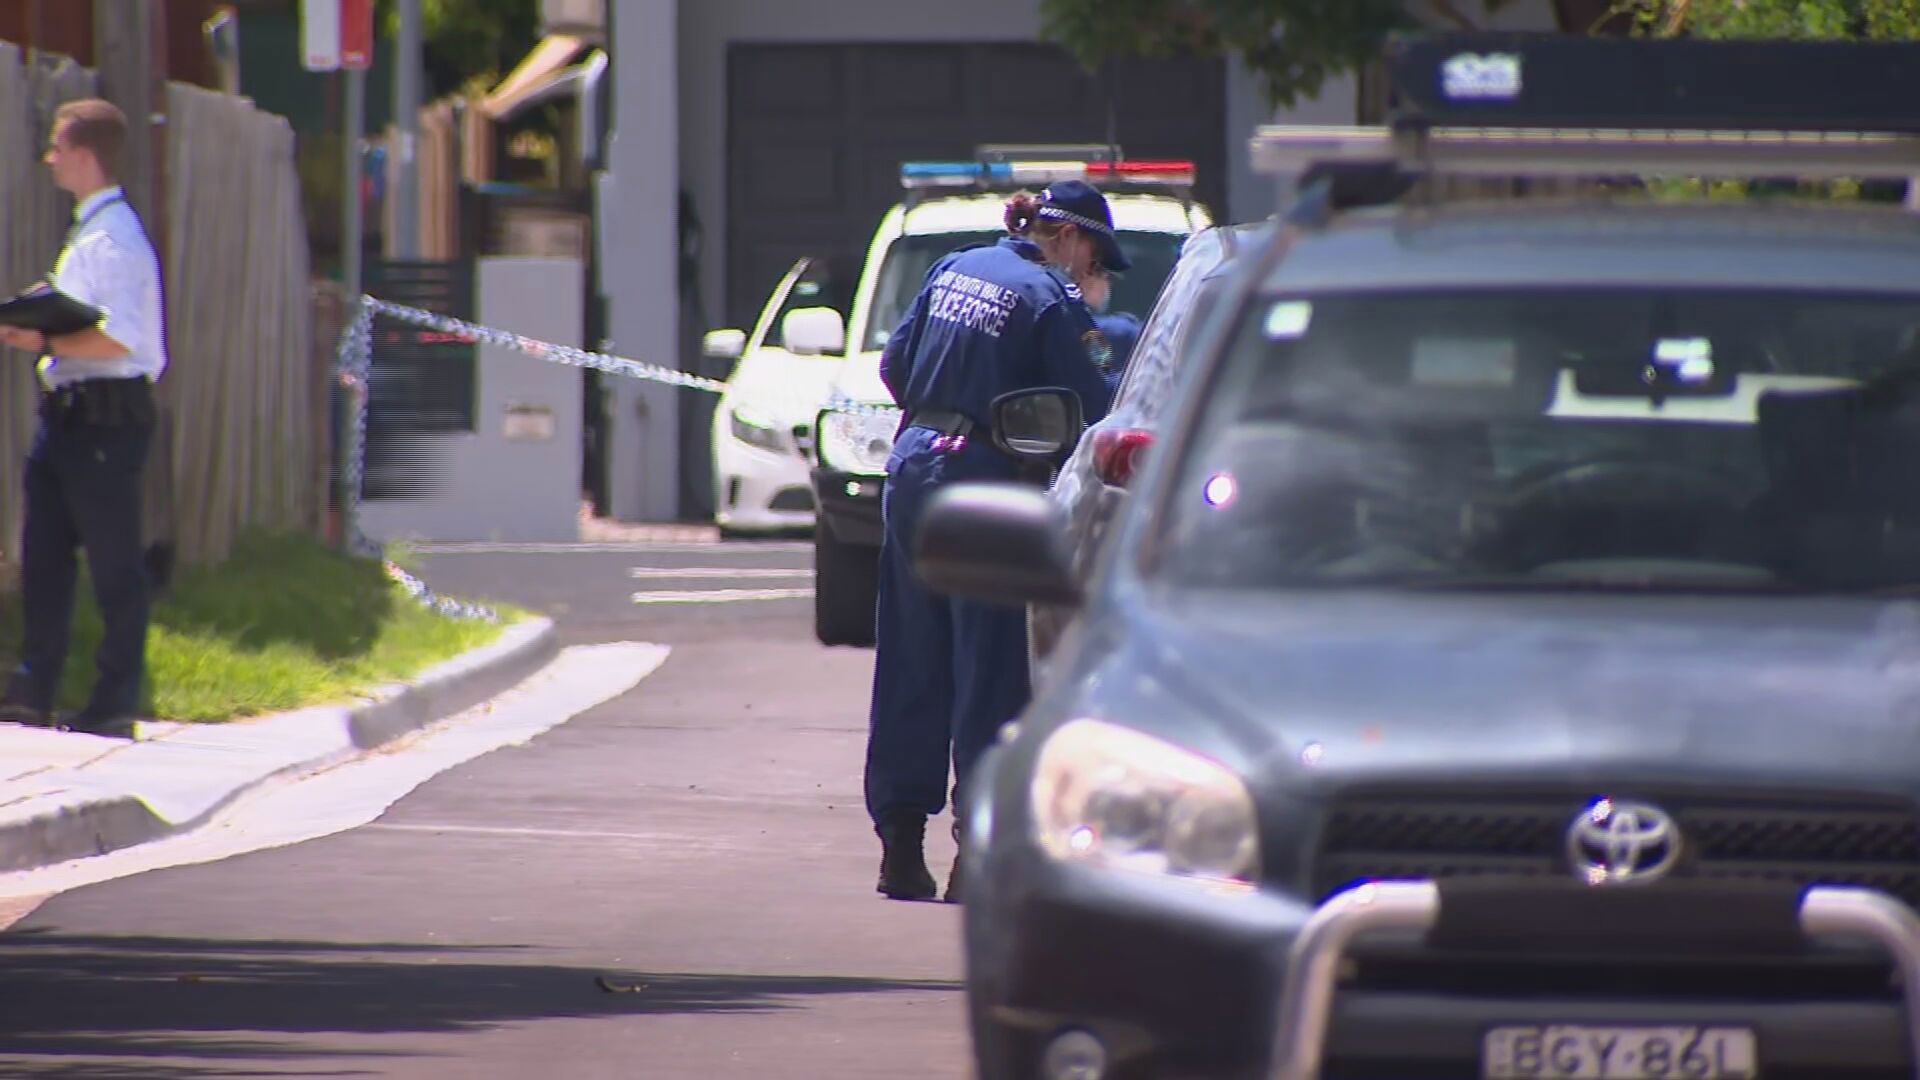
top-left (914, 482), bottom-right (1079, 607)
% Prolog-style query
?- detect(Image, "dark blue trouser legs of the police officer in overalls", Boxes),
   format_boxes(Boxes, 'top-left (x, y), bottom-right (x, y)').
top-left (866, 429), bottom-right (1027, 822)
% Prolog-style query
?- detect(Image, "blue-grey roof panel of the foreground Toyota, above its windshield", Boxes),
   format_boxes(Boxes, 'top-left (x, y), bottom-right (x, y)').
top-left (1267, 200), bottom-right (1920, 292)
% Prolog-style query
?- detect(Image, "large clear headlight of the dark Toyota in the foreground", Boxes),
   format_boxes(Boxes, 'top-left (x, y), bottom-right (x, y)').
top-left (1033, 721), bottom-right (1260, 886)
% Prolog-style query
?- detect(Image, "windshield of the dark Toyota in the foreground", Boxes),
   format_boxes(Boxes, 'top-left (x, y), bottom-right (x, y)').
top-left (1164, 288), bottom-right (1920, 590)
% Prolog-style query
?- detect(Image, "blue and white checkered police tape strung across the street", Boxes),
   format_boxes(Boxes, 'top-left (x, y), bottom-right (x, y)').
top-left (334, 296), bottom-right (900, 621)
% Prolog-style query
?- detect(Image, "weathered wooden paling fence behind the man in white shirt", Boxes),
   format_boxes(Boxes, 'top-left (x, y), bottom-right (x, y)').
top-left (0, 42), bottom-right (332, 563)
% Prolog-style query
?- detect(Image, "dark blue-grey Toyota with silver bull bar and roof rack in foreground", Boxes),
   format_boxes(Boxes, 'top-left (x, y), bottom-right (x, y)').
top-left (916, 35), bottom-right (1920, 1080)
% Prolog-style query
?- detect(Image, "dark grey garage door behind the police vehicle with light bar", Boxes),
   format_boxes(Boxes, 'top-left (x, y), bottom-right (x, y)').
top-left (726, 44), bottom-right (1227, 327)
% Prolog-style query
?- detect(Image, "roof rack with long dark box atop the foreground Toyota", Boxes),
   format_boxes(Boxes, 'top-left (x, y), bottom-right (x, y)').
top-left (1252, 33), bottom-right (1920, 179)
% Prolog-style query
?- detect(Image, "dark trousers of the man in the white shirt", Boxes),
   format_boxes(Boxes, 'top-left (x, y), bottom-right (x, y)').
top-left (8, 413), bottom-right (154, 719)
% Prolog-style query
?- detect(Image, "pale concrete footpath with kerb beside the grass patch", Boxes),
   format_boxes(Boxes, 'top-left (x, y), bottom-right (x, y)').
top-left (0, 619), bottom-right (559, 872)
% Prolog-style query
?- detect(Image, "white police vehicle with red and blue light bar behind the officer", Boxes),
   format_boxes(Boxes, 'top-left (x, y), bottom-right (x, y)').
top-left (812, 146), bottom-right (1212, 646)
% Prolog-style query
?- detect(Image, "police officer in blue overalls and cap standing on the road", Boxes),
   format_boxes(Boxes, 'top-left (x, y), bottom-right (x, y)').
top-left (866, 181), bottom-right (1129, 901)
